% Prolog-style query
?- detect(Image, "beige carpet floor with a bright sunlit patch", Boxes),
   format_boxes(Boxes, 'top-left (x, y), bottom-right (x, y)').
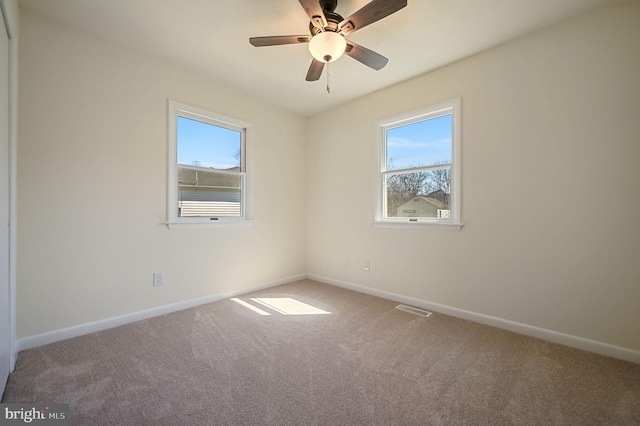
top-left (3, 280), bottom-right (640, 425)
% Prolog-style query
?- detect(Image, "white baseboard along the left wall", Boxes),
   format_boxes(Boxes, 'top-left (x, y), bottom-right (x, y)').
top-left (16, 274), bottom-right (307, 351)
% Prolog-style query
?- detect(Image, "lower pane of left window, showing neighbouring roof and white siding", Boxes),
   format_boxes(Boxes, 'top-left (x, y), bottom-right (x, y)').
top-left (178, 166), bottom-right (242, 217)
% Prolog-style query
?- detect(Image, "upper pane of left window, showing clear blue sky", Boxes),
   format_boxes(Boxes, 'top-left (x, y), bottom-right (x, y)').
top-left (177, 117), bottom-right (242, 171)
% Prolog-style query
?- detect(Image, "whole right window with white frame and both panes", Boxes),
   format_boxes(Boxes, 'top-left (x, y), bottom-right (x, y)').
top-left (376, 99), bottom-right (462, 229)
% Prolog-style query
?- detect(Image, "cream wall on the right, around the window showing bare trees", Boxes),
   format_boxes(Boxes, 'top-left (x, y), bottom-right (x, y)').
top-left (307, 1), bottom-right (640, 350)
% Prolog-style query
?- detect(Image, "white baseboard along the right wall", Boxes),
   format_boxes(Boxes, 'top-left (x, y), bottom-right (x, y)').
top-left (307, 274), bottom-right (640, 364)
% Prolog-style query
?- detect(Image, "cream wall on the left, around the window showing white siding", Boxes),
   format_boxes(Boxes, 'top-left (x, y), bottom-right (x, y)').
top-left (17, 10), bottom-right (306, 338)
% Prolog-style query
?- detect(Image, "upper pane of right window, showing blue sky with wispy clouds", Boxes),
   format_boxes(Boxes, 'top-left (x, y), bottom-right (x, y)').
top-left (386, 114), bottom-right (452, 170)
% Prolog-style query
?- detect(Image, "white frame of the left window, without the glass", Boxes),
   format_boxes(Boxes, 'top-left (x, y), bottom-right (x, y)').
top-left (166, 99), bottom-right (253, 229)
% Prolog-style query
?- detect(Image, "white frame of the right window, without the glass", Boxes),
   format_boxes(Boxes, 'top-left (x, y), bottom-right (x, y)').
top-left (374, 98), bottom-right (463, 231)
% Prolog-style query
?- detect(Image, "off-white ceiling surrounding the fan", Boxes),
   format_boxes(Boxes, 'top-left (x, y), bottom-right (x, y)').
top-left (20, 0), bottom-right (608, 116)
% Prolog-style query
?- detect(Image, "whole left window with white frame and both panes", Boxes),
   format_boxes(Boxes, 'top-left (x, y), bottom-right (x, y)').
top-left (167, 101), bottom-right (250, 228)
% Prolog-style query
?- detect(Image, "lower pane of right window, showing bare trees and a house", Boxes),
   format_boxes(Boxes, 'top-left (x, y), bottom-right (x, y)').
top-left (385, 167), bottom-right (451, 219)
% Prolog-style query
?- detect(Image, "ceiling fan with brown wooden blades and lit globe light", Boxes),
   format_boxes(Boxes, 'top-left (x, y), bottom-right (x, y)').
top-left (249, 0), bottom-right (407, 81)
